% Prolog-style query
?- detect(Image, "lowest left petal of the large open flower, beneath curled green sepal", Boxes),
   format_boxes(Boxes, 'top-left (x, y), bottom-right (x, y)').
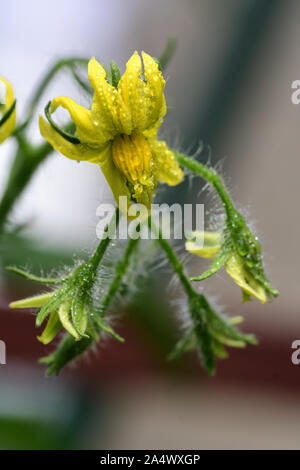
top-left (39, 116), bottom-right (103, 163)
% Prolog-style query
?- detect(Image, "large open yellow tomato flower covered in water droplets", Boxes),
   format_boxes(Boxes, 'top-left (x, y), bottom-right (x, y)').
top-left (40, 52), bottom-right (183, 208)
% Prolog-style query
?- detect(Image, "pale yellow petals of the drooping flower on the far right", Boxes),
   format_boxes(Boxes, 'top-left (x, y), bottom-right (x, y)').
top-left (185, 232), bottom-right (267, 303)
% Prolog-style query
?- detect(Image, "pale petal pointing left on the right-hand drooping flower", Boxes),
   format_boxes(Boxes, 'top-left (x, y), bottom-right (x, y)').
top-left (185, 231), bottom-right (222, 258)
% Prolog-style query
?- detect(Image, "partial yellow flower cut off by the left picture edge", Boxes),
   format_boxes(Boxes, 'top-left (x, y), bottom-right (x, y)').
top-left (0, 77), bottom-right (16, 144)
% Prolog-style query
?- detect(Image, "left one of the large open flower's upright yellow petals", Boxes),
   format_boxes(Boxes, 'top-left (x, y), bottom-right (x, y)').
top-left (88, 57), bottom-right (132, 139)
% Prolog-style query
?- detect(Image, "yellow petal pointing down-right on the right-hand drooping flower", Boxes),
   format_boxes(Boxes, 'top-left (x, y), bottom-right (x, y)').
top-left (225, 253), bottom-right (267, 303)
